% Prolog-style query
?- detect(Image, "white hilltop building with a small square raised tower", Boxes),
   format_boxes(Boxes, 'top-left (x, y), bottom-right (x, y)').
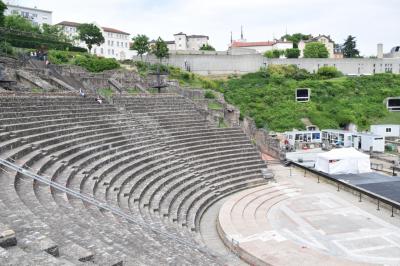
top-left (166, 32), bottom-right (209, 51)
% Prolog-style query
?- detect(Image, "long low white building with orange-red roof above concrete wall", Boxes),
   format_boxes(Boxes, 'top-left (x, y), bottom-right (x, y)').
top-left (229, 40), bottom-right (293, 54)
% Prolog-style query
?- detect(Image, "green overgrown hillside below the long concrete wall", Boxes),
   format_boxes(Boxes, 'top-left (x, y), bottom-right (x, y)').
top-left (221, 69), bottom-right (400, 131)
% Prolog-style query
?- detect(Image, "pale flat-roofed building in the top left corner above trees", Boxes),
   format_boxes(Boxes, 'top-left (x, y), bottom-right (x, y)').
top-left (4, 4), bottom-right (52, 26)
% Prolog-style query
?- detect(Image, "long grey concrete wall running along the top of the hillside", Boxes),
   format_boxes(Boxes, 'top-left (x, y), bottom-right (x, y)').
top-left (134, 54), bottom-right (400, 75)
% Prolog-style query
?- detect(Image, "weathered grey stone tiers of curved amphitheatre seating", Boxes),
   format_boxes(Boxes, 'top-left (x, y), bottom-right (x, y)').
top-left (0, 94), bottom-right (265, 265)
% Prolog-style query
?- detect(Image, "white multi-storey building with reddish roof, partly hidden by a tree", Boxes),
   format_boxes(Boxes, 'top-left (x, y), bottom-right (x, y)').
top-left (57, 21), bottom-right (133, 60)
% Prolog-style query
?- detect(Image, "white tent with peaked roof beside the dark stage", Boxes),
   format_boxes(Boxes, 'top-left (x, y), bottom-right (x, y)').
top-left (315, 148), bottom-right (371, 175)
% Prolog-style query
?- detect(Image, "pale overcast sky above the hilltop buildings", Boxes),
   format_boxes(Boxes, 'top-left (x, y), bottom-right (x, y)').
top-left (5, 0), bottom-right (400, 55)
